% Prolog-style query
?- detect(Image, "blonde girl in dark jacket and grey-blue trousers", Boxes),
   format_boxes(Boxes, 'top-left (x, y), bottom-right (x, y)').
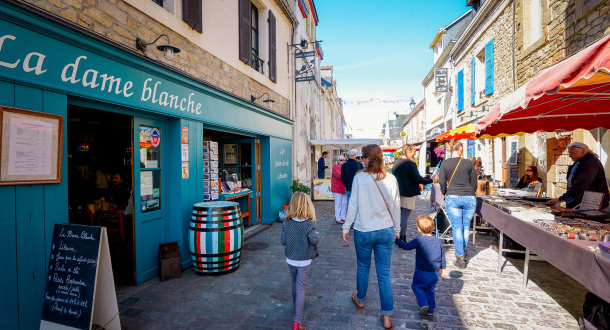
top-left (280, 192), bottom-right (320, 330)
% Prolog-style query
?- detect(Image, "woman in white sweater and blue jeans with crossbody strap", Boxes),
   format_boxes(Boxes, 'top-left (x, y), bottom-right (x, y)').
top-left (343, 144), bottom-right (400, 329)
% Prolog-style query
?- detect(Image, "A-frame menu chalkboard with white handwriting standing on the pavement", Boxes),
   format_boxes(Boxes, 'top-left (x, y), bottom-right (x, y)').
top-left (40, 224), bottom-right (120, 329)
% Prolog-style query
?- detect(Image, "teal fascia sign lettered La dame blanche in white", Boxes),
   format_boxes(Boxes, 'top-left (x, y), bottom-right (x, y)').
top-left (0, 21), bottom-right (210, 119)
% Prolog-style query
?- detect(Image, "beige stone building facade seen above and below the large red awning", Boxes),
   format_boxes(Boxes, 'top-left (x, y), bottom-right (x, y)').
top-left (515, 0), bottom-right (610, 197)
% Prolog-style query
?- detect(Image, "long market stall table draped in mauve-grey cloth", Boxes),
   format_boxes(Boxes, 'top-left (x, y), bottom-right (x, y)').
top-left (476, 198), bottom-right (610, 301)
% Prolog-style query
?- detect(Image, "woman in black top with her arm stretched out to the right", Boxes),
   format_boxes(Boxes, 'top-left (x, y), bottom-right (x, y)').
top-left (392, 144), bottom-right (438, 242)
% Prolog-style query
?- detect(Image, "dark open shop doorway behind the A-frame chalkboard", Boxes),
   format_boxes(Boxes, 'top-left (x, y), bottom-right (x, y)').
top-left (67, 106), bottom-right (135, 285)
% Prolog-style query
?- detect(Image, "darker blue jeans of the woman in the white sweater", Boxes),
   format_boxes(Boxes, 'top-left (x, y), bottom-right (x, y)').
top-left (354, 227), bottom-right (394, 315)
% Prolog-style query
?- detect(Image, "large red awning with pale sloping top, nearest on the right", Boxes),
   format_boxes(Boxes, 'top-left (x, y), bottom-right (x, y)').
top-left (476, 36), bottom-right (610, 138)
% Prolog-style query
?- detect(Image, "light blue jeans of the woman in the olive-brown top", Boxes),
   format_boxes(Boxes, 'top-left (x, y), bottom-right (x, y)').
top-left (445, 195), bottom-right (477, 257)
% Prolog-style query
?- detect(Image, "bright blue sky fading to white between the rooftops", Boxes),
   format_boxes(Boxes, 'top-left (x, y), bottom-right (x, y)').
top-left (315, 0), bottom-right (470, 137)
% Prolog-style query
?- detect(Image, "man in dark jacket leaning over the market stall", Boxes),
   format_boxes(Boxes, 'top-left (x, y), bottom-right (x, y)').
top-left (550, 142), bottom-right (610, 208)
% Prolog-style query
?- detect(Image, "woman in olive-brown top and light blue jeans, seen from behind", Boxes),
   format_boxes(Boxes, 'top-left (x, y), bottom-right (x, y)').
top-left (439, 139), bottom-right (477, 269)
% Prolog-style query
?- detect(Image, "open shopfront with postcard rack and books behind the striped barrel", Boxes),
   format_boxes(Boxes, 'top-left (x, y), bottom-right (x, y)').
top-left (203, 130), bottom-right (262, 227)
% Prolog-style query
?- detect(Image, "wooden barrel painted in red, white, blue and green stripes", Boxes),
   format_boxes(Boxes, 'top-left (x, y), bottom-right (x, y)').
top-left (189, 201), bottom-right (244, 275)
